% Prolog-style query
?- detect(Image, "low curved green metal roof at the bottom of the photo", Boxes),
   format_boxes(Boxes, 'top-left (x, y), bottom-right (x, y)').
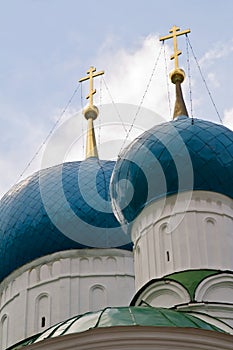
top-left (10, 306), bottom-right (224, 350)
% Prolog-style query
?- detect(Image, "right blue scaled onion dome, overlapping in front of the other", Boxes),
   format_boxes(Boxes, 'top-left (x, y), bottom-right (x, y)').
top-left (111, 116), bottom-right (233, 223)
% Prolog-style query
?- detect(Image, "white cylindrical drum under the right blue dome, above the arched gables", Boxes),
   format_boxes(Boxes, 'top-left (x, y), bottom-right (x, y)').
top-left (132, 191), bottom-right (233, 290)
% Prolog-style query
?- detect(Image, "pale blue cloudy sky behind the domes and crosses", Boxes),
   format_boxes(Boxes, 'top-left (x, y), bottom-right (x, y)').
top-left (0, 0), bottom-right (233, 196)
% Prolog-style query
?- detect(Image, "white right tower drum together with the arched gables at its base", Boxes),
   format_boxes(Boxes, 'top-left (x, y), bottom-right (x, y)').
top-left (132, 191), bottom-right (233, 333)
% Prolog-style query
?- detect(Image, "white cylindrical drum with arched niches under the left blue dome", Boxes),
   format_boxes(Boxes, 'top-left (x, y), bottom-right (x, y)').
top-left (0, 249), bottom-right (135, 350)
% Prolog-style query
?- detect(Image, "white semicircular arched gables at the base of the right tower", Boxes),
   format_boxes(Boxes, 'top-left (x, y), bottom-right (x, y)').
top-left (135, 273), bottom-right (233, 334)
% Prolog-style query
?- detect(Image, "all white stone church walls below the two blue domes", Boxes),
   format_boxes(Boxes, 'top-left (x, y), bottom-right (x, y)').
top-left (0, 191), bottom-right (233, 350)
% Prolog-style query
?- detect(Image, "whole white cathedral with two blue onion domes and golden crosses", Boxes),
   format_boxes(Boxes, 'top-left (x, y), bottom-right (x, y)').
top-left (0, 26), bottom-right (233, 350)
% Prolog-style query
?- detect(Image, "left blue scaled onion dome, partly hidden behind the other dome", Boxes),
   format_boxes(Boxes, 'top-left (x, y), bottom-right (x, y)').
top-left (0, 158), bottom-right (132, 281)
